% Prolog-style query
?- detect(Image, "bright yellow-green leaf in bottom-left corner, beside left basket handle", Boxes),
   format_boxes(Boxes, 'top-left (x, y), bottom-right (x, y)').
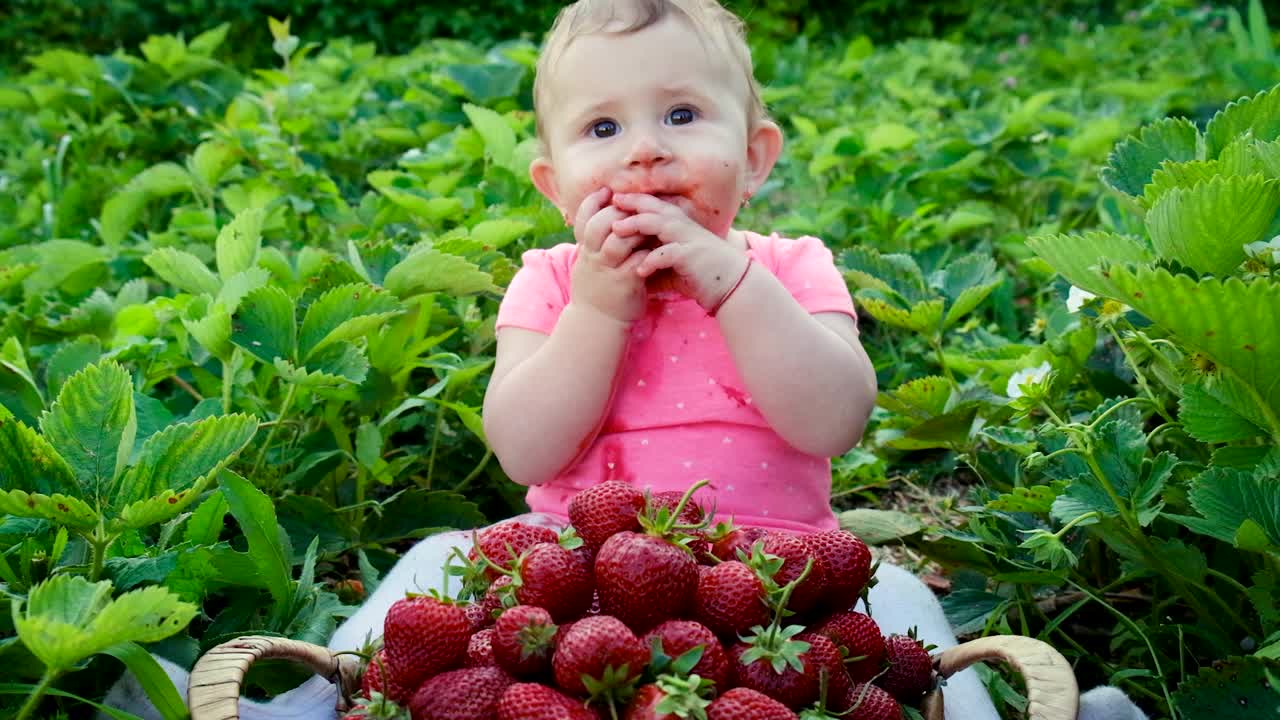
top-left (13, 575), bottom-right (196, 670)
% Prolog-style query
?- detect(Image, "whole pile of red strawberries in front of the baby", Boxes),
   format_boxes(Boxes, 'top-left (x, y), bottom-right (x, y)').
top-left (348, 482), bottom-right (934, 720)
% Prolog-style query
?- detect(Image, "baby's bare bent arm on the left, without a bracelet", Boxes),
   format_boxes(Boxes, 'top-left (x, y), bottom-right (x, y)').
top-left (484, 302), bottom-right (628, 486)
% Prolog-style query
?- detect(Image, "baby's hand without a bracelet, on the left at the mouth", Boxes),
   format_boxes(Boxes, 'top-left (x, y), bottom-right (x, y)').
top-left (570, 187), bottom-right (649, 324)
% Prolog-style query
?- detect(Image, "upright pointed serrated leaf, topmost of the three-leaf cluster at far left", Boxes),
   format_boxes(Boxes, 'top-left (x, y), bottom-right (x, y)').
top-left (40, 360), bottom-right (137, 503)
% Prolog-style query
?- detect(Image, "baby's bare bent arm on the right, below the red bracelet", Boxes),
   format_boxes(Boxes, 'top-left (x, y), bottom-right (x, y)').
top-left (716, 264), bottom-right (876, 457)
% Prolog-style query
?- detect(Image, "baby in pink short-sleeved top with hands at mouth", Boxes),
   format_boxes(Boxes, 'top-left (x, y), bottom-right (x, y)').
top-left (484, 0), bottom-right (876, 532)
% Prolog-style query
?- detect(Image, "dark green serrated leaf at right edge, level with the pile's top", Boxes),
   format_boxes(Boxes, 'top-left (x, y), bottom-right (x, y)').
top-left (1169, 468), bottom-right (1280, 546)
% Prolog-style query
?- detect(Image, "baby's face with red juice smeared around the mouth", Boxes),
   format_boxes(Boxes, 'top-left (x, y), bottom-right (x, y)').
top-left (530, 17), bottom-right (777, 237)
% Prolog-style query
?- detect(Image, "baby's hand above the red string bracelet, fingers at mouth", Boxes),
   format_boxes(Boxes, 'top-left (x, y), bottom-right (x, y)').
top-left (612, 193), bottom-right (746, 310)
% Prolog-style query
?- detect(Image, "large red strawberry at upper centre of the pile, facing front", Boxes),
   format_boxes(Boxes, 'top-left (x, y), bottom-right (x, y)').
top-left (595, 532), bottom-right (698, 633)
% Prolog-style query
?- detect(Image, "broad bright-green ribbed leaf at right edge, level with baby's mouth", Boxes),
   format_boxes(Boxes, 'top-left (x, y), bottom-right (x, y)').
top-left (1147, 176), bottom-right (1280, 275)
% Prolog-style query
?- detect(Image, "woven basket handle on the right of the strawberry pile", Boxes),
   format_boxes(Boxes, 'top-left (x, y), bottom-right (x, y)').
top-left (924, 635), bottom-right (1080, 720)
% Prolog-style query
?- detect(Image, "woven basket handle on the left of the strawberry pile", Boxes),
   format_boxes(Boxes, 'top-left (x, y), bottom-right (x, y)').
top-left (187, 635), bottom-right (360, 720)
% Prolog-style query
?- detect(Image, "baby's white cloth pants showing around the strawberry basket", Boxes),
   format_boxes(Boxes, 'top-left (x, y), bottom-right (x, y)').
top-left (99, 515), bottom-right (1147, 720)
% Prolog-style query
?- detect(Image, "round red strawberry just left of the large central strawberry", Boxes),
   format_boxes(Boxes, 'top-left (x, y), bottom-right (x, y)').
top-left (512, 542), bottom-right (593, 623)
